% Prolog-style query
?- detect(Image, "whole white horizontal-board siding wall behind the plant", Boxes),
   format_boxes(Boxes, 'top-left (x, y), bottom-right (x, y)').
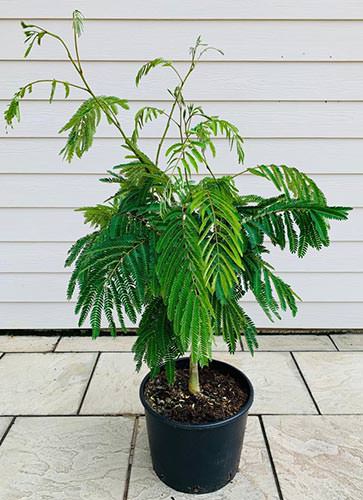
top-left (0, 0), bottom-right (363, 329)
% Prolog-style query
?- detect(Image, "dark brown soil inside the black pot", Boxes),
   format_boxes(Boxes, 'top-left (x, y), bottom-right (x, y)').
top-left (145, 367), bottom-right (247, 424)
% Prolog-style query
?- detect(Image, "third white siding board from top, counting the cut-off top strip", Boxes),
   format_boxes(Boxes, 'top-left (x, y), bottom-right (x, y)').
top-left (0, 60), bottom-right (363, 101)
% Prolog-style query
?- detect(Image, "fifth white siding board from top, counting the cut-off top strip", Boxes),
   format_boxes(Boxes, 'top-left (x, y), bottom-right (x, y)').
top-left (0, 137), bottom-right (363, 175)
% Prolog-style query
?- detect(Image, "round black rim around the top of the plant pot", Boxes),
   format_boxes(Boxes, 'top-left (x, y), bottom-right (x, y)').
top-left (139, 357), bottom-right (254, 431)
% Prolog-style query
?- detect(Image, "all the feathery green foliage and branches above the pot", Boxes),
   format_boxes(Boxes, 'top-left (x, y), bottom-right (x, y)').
top-left (5, 11), bottom-right (350, 382)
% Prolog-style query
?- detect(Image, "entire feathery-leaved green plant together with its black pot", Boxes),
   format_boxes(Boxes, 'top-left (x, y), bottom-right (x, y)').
top-left (5, 11), bottom-right (349, 493)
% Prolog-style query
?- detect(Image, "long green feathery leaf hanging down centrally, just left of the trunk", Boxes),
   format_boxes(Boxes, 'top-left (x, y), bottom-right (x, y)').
top-left (156, 207), bottom-right (214, 366)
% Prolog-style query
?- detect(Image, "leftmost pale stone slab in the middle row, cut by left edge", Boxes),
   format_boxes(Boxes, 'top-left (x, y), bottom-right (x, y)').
top-left (0, 353), bottom-right (97, 415)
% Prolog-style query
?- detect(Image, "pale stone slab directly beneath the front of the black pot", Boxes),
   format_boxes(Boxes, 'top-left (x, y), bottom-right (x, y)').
top-left (128, 417), bottom-right (279, 500)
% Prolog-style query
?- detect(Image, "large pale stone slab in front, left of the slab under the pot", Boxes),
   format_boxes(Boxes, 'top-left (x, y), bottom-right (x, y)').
top-left (0, 417), bottom-right (134, 500)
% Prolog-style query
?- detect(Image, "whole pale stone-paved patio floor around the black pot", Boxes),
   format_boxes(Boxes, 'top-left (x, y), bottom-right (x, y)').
top-left (0, 334), bottom-right (363, 500)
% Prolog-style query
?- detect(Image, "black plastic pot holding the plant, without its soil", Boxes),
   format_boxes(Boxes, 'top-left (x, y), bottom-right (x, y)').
top-left (140, 358), bottom-right (253, 493)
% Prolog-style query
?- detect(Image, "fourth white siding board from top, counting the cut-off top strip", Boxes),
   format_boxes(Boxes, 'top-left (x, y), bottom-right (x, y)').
top-left (0, 100), bottom-right (363, 138)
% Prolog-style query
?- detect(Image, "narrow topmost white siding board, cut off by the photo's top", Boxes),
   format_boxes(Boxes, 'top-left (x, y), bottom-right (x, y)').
top-left (1, 0), bottom-right (363, 20)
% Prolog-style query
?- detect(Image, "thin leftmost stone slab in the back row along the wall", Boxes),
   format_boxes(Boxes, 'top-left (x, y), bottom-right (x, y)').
top-left (0, 335), bottom-right (59, 352)
